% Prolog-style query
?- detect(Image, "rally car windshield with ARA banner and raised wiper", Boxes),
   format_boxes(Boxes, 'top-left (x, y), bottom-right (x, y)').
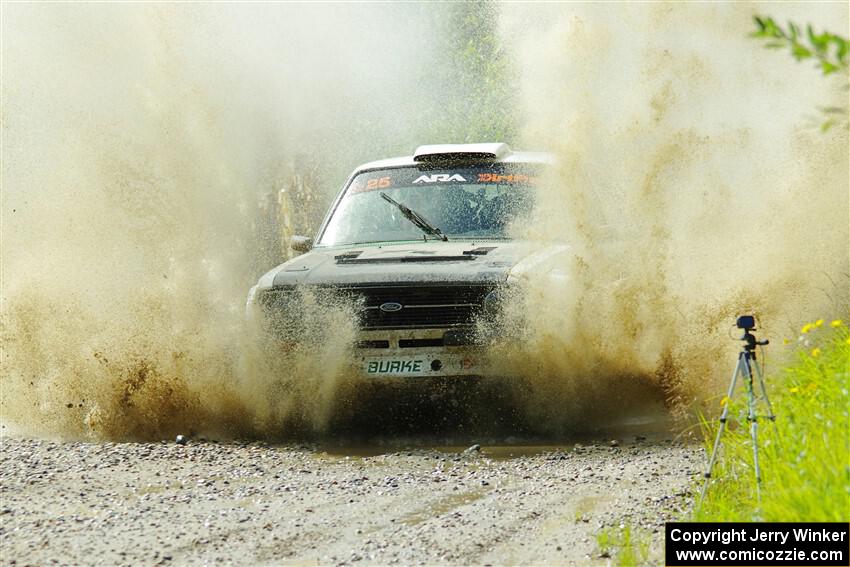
top-left (319, 164), bottom-right (540, 246)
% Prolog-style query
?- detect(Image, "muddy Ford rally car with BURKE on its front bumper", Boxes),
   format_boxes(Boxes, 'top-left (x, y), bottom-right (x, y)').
top-left (247, 143), bottom-right (565, 380)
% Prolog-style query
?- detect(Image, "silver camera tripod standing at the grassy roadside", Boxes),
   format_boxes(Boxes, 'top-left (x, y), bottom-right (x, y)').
top-left (699, 327), bottom-right (776, 506)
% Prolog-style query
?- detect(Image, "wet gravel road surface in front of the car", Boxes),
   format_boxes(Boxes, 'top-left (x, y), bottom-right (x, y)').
top-left (0, 430), bottom-right (703, 565)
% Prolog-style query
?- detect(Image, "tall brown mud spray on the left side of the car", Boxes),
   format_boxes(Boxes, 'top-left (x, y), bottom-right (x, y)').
top-left (0, 4), bottom-right (425, 439)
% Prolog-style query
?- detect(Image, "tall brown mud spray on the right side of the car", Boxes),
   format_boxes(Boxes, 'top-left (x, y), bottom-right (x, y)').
top-left (496, 4), bottom-right (850, 431)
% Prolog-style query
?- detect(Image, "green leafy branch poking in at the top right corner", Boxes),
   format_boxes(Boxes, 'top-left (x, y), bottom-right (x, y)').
top-left (750, 16), bottom-right (850, 132)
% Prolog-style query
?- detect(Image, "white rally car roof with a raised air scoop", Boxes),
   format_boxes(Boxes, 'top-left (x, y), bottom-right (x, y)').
top-left (355, 143), bottom-right (554, 174)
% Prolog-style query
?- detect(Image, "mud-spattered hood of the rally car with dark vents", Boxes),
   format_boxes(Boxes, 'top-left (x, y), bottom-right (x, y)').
top-left (252, 241), bottom-right (569, 289)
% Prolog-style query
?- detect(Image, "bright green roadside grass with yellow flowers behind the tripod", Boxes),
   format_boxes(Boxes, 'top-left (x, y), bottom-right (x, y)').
top-left (693, 320), bottom-right (850, 521)
